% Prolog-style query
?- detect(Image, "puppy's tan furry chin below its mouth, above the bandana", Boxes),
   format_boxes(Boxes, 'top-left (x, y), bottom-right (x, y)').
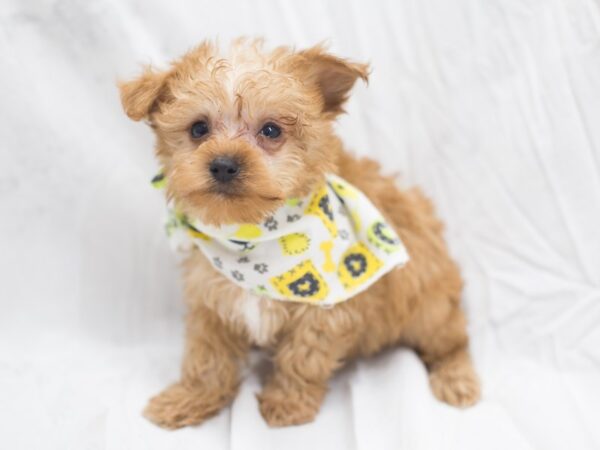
top-left (178, 188), bottom-right (284, 226)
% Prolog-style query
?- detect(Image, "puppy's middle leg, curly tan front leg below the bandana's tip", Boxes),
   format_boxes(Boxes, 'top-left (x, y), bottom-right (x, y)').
top-left (257, 306), bottom-right (353, 426)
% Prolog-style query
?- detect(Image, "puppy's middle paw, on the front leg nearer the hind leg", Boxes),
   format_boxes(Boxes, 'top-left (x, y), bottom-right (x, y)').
top-left (257, 388), bottom-right (321, 427)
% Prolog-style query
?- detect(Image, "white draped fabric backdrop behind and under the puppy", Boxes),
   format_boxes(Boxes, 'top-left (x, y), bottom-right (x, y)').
top-left (0, 0), bottom-right (600, 450)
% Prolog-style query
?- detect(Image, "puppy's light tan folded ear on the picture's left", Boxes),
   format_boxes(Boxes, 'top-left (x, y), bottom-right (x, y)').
top-left (118, 66), bottom-right (169, 121)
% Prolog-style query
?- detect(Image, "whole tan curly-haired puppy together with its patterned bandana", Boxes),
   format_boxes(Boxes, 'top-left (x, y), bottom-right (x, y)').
top-left (120, 39), bottom-right (480, 428)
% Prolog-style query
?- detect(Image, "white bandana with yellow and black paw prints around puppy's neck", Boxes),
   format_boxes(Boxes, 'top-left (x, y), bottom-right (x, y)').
top-left (153, 174), bottom-right (409, 306)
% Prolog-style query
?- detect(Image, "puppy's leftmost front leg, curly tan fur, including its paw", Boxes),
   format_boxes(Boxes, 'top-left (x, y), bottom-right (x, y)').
top-left (144, 306), bottom-right (247, 429)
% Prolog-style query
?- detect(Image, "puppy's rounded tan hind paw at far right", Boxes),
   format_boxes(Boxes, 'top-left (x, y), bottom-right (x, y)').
top-left (429, 362), bottom-right (481, 408)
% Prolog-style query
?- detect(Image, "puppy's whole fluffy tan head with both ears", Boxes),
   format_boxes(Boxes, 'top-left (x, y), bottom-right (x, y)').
top-left (120, 40), bottom-right (367, 225)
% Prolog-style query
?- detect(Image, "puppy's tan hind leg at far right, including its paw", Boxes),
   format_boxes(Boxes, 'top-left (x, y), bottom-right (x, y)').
top-left (406, 299), bottom-right (480, 407)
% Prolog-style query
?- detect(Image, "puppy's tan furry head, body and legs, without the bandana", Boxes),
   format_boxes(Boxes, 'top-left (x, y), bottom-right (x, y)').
top-left (121, 42), bottom-right (479, 428)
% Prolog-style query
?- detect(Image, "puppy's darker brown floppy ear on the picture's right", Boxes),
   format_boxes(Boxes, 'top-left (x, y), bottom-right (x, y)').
top-left (299, 45), bottom-right (369, 115)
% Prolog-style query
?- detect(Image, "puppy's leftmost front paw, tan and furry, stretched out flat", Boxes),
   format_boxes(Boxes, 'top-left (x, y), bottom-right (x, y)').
top-left (143, 383), bottom-right (224, 430)
